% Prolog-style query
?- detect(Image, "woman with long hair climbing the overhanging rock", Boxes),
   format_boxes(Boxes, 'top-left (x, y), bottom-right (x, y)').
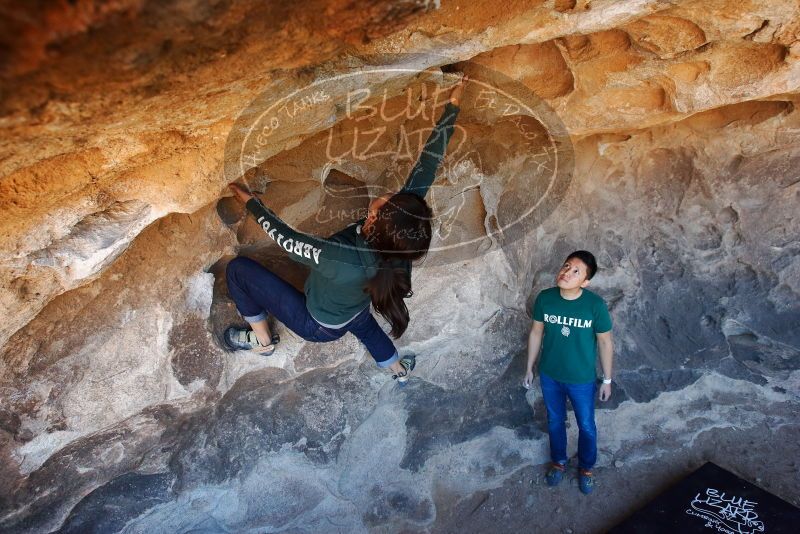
top-left (223, 76), bottom-right (467, 382)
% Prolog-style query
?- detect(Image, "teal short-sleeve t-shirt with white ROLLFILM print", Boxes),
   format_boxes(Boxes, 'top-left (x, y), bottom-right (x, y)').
top-left (533, 287), bottom-right (611, 384)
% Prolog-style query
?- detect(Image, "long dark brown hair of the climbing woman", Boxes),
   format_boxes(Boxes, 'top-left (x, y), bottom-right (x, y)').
top-left (364, 193), bottom-right (433, 339)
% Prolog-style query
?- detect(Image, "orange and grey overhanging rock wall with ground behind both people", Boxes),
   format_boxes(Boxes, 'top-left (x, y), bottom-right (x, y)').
top-left (0, 0), bottom-right (800, 533)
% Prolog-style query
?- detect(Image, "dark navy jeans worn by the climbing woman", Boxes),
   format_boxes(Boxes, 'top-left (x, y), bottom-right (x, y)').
top-left (225, 256), bottom-right (400, 367)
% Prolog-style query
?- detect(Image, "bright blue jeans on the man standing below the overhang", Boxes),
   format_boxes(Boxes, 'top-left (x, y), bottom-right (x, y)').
top-left (539, 373), bottom-right (597, 469)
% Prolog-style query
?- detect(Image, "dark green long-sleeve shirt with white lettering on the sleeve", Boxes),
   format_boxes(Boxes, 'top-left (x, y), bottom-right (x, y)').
top-left (247, 103), bottom-right (459, 325)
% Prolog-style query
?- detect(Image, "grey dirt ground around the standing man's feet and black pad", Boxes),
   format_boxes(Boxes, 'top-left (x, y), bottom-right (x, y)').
top-left (431, 424), bottom-right (800, 534)
